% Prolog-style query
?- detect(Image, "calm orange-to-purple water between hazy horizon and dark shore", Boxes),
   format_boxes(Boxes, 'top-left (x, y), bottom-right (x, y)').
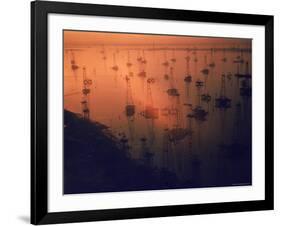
top-left (64, 42), bottom-right (251, 192)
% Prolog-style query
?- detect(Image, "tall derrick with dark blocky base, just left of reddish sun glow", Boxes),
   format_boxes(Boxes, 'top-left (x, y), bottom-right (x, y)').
top-left (125, 76), bottom-right (136, 140)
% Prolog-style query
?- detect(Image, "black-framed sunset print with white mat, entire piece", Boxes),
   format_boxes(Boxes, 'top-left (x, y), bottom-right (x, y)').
top-left (31, 1), bottom-right (273, 224)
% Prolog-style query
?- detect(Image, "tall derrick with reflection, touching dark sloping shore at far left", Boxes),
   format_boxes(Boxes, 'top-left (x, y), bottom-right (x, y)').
top-left (81, 67), bottom-right (92, 120)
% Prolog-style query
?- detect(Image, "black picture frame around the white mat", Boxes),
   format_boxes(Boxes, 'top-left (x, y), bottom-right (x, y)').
top-left (31, 1), bottom-right (274, 224)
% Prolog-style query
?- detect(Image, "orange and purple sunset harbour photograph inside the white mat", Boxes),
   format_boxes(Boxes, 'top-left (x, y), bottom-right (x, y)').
top-left (61, 30), bottom-right (252, 195)
